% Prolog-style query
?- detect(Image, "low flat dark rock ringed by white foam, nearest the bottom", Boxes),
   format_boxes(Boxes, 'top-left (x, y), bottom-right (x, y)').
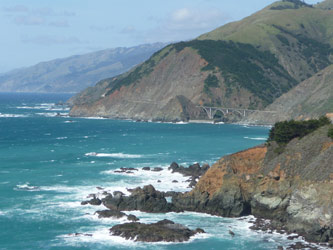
top-left (110, 220), bottom-right (204, 242)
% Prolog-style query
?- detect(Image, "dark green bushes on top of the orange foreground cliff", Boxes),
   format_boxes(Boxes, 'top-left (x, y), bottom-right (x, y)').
top-left (268, 116), bottom-right (331, 146)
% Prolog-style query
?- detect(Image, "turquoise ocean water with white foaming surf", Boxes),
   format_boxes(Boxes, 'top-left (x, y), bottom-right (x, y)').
top-left (0, 94), bottom-right (296, 249)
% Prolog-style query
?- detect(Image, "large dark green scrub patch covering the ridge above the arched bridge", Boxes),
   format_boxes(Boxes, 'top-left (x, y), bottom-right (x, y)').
top-left (174, 40), bottom-right (297, 105)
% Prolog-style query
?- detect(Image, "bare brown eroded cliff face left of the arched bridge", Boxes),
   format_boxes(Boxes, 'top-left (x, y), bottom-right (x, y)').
top-left (70, 48), bottom-right (208, 120)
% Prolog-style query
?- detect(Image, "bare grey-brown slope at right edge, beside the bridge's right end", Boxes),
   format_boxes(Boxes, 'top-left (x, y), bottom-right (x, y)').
top-left (244, 65), bottom-right (333, 124)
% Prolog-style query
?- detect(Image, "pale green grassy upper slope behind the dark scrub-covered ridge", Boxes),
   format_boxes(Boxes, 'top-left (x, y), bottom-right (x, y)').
top-left (199, 1), bottom-right (333, 82)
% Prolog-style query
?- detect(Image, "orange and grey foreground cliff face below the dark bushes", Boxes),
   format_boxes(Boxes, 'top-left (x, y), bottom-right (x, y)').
top-left (173, 126), bottom-right (333, 242)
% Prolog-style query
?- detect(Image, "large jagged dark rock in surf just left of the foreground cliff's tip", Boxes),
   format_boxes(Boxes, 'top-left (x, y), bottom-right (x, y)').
top-left (102, 185), bottom-right (182, 213)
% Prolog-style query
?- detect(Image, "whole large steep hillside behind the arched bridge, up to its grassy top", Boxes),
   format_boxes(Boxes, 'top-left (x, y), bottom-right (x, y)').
top-left (71, 0), bottom-right (333, 120)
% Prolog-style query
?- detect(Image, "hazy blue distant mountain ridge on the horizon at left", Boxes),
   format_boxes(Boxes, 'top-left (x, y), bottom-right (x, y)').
top-left (0, 43), bottom-right (166, 93)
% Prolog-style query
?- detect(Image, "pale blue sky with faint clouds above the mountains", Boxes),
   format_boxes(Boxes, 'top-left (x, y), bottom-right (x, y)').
top-left (0, 0), bottom-right (318, 73)
